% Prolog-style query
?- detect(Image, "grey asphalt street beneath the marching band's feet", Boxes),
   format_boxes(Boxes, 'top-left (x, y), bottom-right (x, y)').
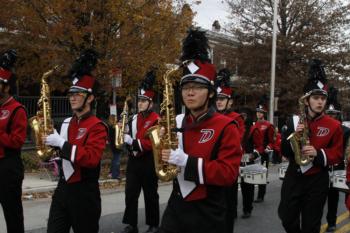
top-left (0, 165), bottom-right (350, 233)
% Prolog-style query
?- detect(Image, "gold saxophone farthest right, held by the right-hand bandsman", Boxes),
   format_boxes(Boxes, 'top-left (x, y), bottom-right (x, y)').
top-left (287, 95), bottom-right (312, 166)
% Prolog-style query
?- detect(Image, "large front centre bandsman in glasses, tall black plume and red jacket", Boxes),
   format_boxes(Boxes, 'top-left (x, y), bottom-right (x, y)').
top-left (160, 29), bottom-right (242, 233)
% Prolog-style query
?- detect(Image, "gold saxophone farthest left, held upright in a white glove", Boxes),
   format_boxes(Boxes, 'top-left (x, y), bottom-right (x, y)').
top-left (29, 65), bottom-right (60, 161)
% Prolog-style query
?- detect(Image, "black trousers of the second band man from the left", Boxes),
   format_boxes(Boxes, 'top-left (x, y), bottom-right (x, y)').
top-left (47, 180), bottom-right (101, 233)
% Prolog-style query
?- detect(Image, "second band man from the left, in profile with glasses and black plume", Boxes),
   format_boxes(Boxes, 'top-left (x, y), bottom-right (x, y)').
top-left (45, 50), bottom-right (108, 233)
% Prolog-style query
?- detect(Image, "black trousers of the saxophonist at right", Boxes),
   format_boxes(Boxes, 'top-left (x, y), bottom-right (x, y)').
top-left (278, 170), bottom-right (329, 233)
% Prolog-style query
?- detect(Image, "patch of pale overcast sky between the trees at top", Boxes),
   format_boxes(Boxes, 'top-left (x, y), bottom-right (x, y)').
top-left (188, 0), bottom-right (229, 29)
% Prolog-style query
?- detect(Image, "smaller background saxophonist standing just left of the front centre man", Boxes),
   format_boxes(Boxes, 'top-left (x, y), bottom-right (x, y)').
top-left (122, 71), bottom-right (159, 233)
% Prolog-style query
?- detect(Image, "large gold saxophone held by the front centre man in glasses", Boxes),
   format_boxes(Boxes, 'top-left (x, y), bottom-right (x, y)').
top-left (147, 67), bottom-right (179, 181)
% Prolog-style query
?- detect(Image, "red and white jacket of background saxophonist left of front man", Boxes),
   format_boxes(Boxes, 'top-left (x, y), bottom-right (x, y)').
top-left (129, 111), bottom-right (159, 157)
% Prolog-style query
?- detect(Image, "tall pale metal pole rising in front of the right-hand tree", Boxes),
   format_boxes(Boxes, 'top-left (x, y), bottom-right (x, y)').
top-left (269, 0), bottom-right (278, 123)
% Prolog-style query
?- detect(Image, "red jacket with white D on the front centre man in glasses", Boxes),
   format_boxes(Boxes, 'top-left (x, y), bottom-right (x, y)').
top-left (174, 110), bottom-right (242, 201)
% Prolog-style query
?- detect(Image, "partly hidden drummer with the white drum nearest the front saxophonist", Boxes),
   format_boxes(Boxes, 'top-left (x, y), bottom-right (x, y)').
top-left (241, 108), bottom-right (264, 219)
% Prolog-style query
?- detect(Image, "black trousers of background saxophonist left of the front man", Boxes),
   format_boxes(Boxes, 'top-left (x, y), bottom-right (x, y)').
top-left (123, 155), bottom-right (159, 227)
